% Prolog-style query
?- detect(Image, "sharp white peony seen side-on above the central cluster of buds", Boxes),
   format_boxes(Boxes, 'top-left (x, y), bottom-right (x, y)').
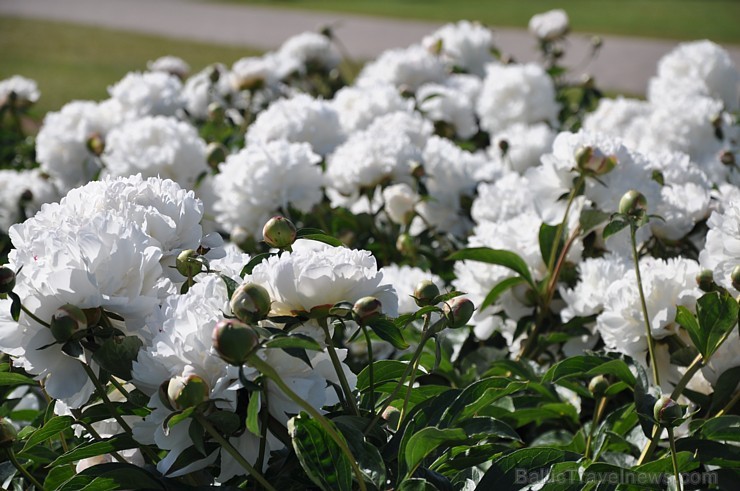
top-left (244, 240), bottom-right (398, 317)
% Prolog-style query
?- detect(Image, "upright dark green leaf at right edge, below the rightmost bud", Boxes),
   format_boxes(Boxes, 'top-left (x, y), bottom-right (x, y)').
top-left (696, 292), bottom-right (738, 357)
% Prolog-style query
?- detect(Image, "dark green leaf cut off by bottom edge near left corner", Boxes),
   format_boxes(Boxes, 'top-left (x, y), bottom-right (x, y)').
top-left (59, 462), bottom-right (166, 491)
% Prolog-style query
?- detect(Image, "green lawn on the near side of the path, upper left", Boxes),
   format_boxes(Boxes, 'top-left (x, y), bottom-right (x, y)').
top-left (0, 17), bottom-right (255, 117)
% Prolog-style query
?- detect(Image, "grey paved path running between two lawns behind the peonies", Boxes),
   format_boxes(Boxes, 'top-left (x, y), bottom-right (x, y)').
top-left (0, 0), bottom-right (740, 94)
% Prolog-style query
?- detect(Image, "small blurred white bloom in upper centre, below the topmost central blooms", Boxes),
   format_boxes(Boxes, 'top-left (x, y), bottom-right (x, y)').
top-left (331, 84), bottom-right (414, 135)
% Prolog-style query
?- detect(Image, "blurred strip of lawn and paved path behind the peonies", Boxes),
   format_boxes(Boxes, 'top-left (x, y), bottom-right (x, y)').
top-left (0, 0), bottom-right (740, 115)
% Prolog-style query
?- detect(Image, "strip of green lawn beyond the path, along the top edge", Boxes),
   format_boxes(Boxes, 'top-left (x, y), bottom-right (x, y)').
top-left (214, 0), bottom-right (740, 44)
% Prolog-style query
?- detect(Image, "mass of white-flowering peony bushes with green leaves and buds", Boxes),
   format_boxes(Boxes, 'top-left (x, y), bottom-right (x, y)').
top-left (0, 10), bottom-right (740, 491)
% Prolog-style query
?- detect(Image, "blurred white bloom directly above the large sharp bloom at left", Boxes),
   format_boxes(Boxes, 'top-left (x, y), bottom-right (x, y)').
top-left (102, 116), bottom-right (208, 189)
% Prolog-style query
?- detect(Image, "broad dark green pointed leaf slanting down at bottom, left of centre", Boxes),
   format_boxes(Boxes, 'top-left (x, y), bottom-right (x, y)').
top-left (288, 413), bottom-right (352, 491)
